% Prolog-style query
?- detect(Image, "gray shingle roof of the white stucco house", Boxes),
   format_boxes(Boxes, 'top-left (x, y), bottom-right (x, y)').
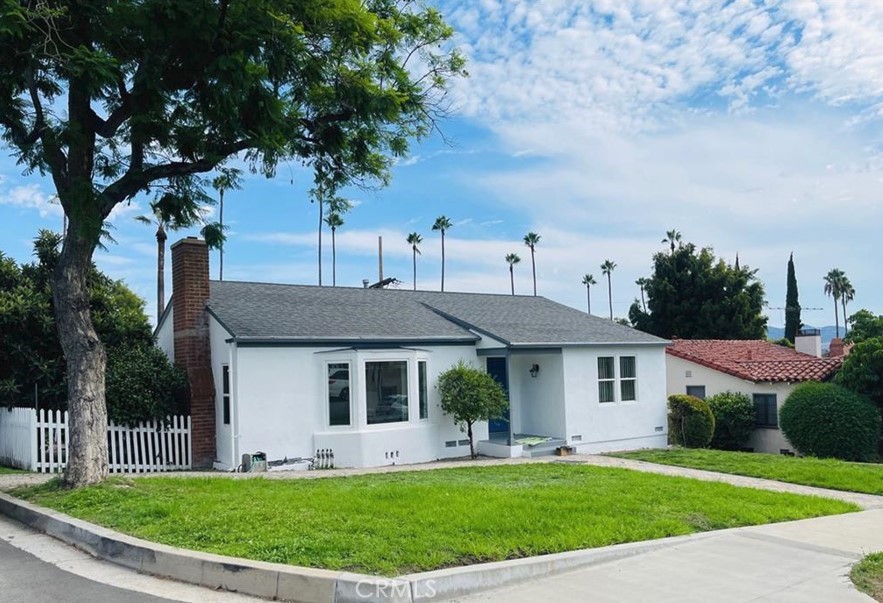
top-left (208, 281), bottom-right (666, 346)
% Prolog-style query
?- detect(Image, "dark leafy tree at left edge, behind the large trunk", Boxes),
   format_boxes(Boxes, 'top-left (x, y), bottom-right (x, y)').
top-left (0, 230), bottom-right (153, 409)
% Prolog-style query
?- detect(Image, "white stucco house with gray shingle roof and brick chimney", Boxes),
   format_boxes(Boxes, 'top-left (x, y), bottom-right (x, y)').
top-left (157, 239), bottom-right (668, 469)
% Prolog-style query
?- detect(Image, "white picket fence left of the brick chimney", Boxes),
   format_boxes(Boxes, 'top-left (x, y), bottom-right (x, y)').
top-left (0, 408), bottom-right (191, 473)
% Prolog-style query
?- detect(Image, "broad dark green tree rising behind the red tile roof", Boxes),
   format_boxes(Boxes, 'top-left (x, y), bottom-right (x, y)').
top-left (629, 243), bottom-right (767, 339)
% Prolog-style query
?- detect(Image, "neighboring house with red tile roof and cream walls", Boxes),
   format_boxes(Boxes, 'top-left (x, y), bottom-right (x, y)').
top-left (666, 339), bottom-right (843, 453)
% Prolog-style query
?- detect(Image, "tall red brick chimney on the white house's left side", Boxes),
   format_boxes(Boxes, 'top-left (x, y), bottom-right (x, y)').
top-left (172, 237), bottom-right (215, 469)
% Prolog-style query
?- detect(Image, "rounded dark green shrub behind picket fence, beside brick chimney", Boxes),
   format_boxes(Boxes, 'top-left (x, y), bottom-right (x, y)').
top-left (105, 345), bottom-right (190, 425)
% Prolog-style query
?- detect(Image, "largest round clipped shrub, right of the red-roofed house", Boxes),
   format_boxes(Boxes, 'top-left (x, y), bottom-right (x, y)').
top-left (779, 382), bottom-right (880, 461)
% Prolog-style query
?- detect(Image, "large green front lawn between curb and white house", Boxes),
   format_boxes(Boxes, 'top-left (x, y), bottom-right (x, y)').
top-left (15, 464), bottom-right (857, 575)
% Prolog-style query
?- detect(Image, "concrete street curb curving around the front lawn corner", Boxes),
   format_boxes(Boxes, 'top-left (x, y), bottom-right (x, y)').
top-left (0, 492), bottom-right (704, 603)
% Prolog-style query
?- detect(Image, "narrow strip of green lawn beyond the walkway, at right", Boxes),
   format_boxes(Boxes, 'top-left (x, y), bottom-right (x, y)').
top-left (612, 448), bottom-right (883, 495)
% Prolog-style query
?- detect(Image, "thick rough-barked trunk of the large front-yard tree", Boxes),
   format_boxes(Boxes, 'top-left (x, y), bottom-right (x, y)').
top-left (52, 220), bottom-right (107, 488)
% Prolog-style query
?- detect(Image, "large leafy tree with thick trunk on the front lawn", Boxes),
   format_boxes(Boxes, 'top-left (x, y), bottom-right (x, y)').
top-left (0, 0), bottom-right (465, 487)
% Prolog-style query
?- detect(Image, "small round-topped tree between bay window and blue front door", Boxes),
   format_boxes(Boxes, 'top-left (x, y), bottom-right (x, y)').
top-left (438, 360), bottom-right (509, 458)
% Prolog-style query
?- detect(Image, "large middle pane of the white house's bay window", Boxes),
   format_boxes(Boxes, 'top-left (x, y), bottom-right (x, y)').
top-left (365, 360), bottom-right (409, 425)
